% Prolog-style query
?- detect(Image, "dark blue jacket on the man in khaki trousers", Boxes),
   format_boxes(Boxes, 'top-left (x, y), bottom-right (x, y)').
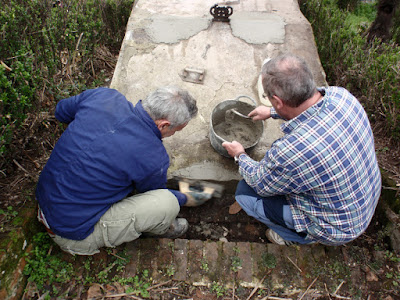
top-left (36, 88), bottom-right (183, 240)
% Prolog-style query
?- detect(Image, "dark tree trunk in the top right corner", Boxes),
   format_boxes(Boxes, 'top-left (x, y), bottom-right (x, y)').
top-left (367, 0), bottom-right (400, 42)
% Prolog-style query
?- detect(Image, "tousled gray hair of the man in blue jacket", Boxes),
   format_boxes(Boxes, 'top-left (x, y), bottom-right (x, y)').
top-left (142, 86), bottom-right (198, 128)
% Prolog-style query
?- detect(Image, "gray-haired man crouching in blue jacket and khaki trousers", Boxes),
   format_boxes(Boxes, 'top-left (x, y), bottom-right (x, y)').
top-left (36, 86), bottom-right (203, 255)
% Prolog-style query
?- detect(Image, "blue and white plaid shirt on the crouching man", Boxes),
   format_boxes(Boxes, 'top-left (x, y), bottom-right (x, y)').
top-left (239, 87), bottom-right (381, 245)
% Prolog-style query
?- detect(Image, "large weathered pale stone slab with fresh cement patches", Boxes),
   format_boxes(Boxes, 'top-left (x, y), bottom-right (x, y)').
top-left (111, 0), bottom-right (325, 182)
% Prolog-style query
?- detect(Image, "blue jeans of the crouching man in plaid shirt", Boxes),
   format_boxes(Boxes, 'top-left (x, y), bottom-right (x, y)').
top-left (235, 180), bottom-right (311, 244)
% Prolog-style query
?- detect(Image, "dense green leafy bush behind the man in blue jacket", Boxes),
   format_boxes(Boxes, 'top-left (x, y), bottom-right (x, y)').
top-left (0, 0), bottom-right (134, 167)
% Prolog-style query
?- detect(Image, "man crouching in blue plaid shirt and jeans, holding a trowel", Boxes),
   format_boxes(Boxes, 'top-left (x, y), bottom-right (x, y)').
top-left (223, 54), bottom-right (381, 245)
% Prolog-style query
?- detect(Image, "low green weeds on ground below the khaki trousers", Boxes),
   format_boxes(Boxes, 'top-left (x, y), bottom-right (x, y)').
top-left (24, 232), bottom-right (152, 299)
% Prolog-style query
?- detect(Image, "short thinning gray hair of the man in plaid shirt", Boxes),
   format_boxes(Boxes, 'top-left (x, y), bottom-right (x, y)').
top-left (261, 54), bottom-right (316, 107)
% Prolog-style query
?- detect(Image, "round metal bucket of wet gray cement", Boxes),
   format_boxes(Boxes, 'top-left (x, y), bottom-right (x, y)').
top-left (209, 96), bottom-right (264, 157)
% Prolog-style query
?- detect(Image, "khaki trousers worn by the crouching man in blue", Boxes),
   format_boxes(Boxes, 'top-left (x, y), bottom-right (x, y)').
top-left (52, 189), bottom-right (179, 255)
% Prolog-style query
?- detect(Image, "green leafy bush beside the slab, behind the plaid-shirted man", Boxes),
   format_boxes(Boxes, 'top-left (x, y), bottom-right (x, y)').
top-left (300, 0), bottom-right (400, 142)
